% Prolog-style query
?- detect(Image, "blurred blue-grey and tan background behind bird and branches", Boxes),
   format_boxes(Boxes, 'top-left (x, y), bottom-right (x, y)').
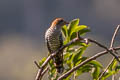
top-left (0, 0), bottom-right (120, 80)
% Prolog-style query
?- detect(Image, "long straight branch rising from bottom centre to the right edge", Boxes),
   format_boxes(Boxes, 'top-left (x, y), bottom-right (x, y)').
top-left (57, 47), bottom-right (120, 80)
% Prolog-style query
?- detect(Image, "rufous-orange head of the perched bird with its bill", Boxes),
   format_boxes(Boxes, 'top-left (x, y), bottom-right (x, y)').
top-left (51, 18), bottom-right (69, 28)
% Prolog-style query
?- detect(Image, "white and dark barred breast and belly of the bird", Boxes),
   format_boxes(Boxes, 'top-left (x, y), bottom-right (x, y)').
top-left (45, 28), bottom-right (63, 53)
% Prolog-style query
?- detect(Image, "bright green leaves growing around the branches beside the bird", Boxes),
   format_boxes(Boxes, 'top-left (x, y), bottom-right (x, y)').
top-left (40, 19), bottom-right (120, 80)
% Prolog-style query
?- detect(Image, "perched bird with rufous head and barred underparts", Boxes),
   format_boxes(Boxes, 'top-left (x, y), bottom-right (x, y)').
top-left (45, 18), bottom-right (68, 73)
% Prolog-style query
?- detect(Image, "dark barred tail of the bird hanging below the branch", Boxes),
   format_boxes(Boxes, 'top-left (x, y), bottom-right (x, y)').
top-left (53, 52), bottom-right (64, 73)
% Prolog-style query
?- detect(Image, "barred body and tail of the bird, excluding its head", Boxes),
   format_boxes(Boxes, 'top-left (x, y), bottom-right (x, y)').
top-left (45, 28), bottom-right (64, 73)
